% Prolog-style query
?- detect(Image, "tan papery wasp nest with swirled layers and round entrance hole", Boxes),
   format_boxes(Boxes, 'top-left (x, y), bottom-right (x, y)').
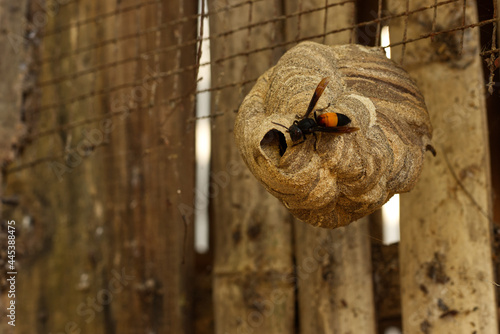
top-left (235, 42), bottom-right (432, 228)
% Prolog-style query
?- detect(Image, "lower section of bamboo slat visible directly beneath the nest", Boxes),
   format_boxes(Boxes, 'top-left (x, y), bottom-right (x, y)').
top-left (295, 218), bottom-right (375, 333)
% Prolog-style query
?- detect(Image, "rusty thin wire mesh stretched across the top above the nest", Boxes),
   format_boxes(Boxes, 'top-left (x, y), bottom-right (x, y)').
top-left (7, 0), bottom-right (500, 172)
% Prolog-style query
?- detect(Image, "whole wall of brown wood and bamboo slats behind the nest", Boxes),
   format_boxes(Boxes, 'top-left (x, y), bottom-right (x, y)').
top-left (0, 0), bottom-right (500, 334)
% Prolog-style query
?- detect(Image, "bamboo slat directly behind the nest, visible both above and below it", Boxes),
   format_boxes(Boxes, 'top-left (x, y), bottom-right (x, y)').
top-left (285, 0), bottom-right (376, 334)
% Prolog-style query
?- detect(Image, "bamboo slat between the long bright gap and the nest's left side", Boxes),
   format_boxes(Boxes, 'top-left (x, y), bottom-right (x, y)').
top-left (208, 0), bottom-right (295, 334)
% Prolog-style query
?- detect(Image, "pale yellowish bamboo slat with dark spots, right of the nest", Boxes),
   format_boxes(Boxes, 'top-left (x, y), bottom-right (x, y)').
top-left (388, 1), bottom-right (498, 334)
